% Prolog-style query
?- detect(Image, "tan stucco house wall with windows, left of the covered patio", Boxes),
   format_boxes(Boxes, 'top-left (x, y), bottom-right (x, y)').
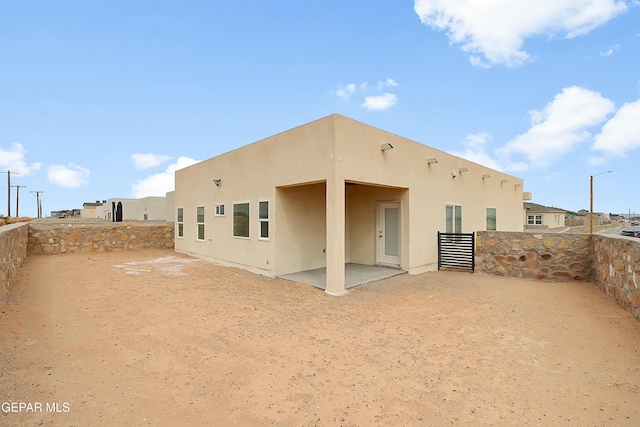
top-left (174, 138), bottom-right (276, 275)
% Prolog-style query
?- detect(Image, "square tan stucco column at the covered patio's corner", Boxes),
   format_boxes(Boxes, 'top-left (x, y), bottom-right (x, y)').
top-left (325, 174), bottom-right (346, 296)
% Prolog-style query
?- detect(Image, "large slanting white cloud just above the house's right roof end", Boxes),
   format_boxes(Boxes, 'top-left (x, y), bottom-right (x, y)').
top-left (497, 86), bottom-right (615, 168)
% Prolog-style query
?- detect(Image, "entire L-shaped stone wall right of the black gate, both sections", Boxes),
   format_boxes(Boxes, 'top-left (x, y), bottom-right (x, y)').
top-left (476, 231), bottom-right (640, 320)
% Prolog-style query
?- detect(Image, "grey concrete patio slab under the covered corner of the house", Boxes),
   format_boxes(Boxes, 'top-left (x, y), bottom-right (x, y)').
top-left (278, 263), bottom-right (406, 289)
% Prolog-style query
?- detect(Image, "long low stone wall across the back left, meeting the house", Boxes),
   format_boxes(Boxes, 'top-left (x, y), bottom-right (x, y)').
top-left (27, 219), bottom-right (174, 254)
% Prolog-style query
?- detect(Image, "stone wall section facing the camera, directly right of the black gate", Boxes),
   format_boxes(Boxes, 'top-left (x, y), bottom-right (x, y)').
top-left (476, 231), bottom-right (593, 281)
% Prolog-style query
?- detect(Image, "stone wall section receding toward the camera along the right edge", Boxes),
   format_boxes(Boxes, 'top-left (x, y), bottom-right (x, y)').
top-left (593, 235), bottom-right (640, 320)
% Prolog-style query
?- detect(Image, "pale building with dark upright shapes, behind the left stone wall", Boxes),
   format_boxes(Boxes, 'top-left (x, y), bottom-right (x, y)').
top-left (96, 197), bottom-right (173, 222)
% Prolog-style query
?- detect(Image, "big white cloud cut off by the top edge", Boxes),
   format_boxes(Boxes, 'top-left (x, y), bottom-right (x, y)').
top-left (414, 0), bottom-right (627, 67)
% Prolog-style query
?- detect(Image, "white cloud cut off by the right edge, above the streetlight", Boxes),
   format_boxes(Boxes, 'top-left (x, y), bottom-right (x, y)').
top-left (593, 99), bottom-right (640, 156)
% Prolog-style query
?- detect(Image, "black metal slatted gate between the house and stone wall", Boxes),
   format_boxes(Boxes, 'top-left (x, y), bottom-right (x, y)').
top-left (438, 232), bottom-right (476, 272)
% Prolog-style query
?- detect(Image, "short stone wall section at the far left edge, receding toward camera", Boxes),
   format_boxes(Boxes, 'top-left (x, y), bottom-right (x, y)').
top-left (0, 222), bottom-right (29, 301)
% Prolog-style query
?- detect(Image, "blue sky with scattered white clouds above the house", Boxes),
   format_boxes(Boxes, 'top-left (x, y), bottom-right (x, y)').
top-left (0, 0), bottom-right (640, 216)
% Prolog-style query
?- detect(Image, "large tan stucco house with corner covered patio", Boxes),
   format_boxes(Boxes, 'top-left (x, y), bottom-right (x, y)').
top-left (174, 115), bottom-right (523, 295)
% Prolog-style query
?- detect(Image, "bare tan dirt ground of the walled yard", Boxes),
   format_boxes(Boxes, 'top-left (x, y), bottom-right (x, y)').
top-left (0, 250), bottom-right (640, 427)
